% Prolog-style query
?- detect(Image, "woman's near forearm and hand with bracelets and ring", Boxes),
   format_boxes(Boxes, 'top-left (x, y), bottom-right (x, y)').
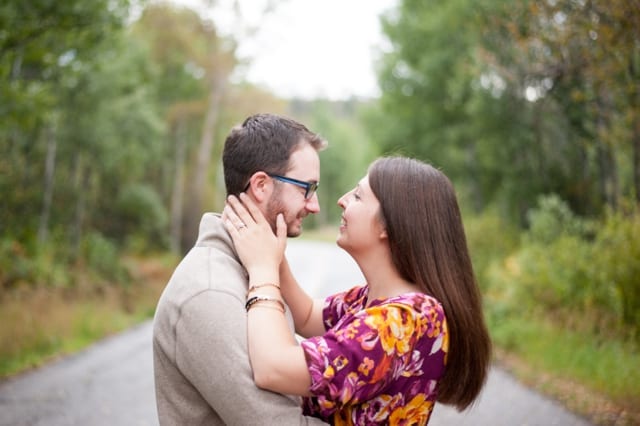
top-left (223, 194), bottom-right (311, 396)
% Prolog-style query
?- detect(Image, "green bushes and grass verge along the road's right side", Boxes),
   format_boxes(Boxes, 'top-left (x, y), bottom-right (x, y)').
top-left (465, 201), bottom-right (640, 425)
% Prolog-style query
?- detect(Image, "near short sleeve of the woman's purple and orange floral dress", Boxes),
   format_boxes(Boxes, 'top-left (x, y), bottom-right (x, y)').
top-left (301, 303), bottom-right (444, 416)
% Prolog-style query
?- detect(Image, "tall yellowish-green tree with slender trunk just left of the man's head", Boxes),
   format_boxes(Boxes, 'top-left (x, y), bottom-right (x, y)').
top-left (134, 4), bottom-right (242, 251)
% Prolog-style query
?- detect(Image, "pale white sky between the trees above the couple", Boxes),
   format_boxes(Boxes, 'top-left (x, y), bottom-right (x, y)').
top-left (173, 0), bottom-right (397, 99)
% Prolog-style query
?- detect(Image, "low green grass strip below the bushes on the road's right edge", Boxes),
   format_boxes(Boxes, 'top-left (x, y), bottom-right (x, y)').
top-left (490, 317), bottom-right (640, 425)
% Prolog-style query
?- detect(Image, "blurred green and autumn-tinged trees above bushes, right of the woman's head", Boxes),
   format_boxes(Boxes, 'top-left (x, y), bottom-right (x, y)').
top-left (376, 0), bottom-right (640, 220)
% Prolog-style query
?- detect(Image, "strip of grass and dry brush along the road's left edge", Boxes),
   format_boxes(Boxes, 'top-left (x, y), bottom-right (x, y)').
top-left (0, 257), bottom-right (176, 378)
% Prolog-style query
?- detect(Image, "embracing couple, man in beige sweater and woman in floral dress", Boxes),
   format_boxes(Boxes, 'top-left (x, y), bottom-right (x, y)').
top-left (153, 114), bottom-right (491, 425)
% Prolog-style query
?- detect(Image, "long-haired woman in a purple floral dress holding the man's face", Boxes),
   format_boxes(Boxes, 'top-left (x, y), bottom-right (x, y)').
top-left (225, 157), bottom-right (491, 425)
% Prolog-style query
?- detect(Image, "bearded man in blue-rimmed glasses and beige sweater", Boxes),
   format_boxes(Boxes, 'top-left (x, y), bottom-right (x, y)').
top-left (153, 114), bottom-right (326, 425)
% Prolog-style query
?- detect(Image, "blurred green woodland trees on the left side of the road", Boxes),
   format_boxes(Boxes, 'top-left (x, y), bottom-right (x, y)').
top-left (0, 0), bottom-right (240, 285)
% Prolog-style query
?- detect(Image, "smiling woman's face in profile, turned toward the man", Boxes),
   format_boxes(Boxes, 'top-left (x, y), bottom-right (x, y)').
top-left (337, 175), bottom-right (386, 254)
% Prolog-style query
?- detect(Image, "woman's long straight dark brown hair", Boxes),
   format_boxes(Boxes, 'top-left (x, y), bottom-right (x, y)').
top-left (369, 157), bottom-right (491, 410)
